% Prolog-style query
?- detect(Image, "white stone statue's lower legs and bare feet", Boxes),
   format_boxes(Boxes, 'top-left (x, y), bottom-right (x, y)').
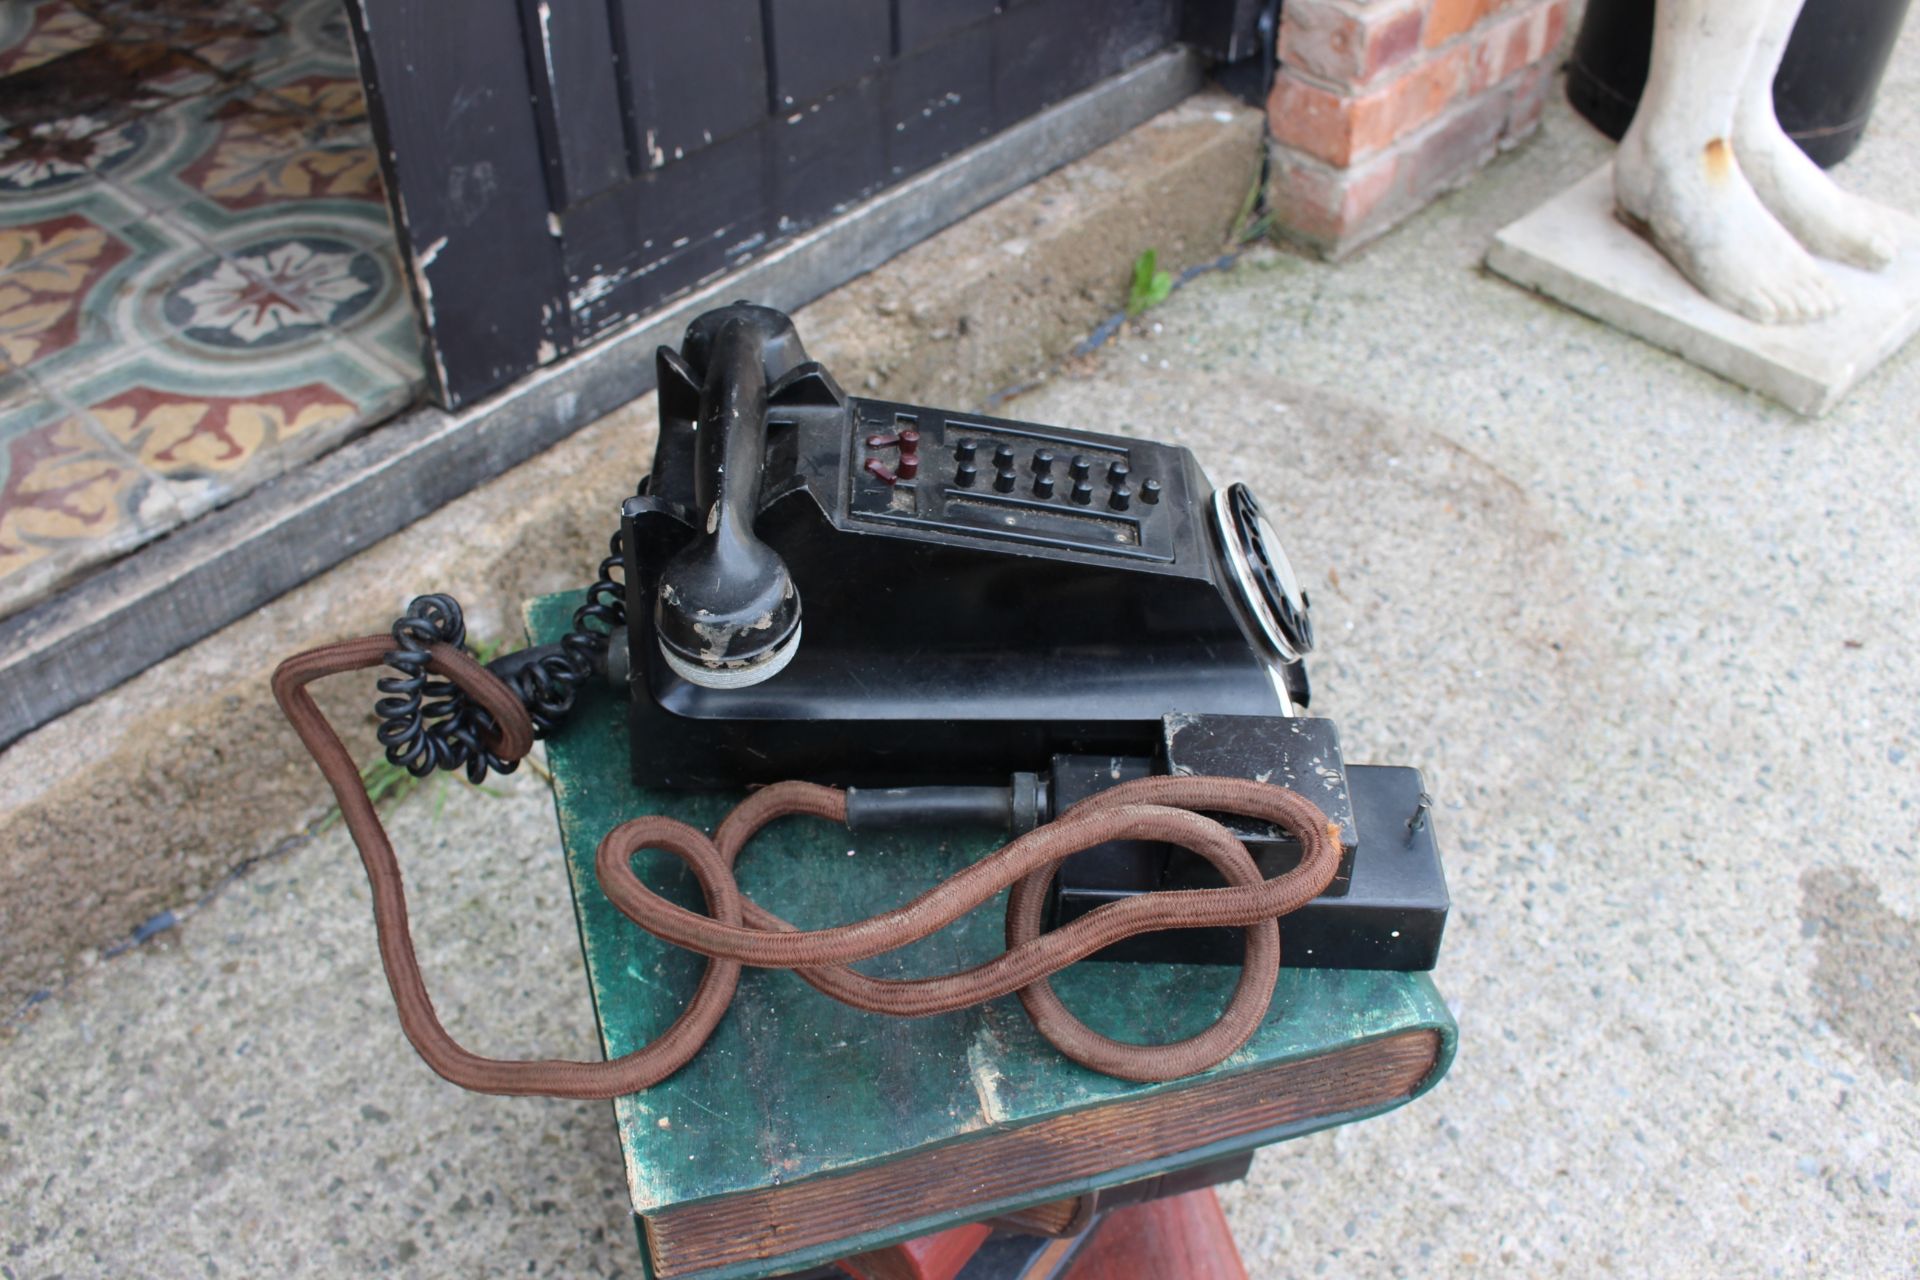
top-left (1613, 0), bottom-right (1897, 324)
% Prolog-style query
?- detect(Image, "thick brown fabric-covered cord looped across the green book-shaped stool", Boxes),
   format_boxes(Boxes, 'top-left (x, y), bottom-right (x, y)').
top-left (273, 635), bottom-right (1340, 1098)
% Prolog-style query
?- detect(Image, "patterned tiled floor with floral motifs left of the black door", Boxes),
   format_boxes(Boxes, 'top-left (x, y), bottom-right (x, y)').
top-left (0, 0), bottom-right (422, 616)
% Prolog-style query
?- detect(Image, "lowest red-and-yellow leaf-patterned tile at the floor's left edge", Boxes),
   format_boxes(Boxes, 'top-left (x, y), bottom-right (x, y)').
top-left (0, 403), bottom-right (179, 614)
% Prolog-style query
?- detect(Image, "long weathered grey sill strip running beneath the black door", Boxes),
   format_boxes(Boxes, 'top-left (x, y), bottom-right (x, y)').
top-left (0, 48), bottom-right (1204, 748)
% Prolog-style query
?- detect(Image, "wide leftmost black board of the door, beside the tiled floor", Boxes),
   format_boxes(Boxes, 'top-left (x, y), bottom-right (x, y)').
top-left (348, 0), bottom-right (572, 409)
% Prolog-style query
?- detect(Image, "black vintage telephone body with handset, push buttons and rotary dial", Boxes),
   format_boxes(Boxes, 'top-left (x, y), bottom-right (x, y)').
top-left (620, 305), bottom-right (1313, 789)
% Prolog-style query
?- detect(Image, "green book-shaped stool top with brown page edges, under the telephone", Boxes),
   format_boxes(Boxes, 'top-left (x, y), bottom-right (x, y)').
top-left (528, 595), bottom-right (1455, 1278)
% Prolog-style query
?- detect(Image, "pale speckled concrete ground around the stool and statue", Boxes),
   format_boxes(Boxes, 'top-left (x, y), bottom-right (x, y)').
top-left (0, 55), bottom-right (1920, 1278)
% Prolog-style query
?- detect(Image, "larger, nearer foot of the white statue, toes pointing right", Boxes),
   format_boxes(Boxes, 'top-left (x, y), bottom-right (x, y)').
top-left (1613, 121), bottom-right (1839, 324)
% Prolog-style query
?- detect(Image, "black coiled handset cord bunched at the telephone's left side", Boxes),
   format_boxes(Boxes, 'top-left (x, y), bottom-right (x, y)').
top-left (372, 530), bottom-right (626, 783)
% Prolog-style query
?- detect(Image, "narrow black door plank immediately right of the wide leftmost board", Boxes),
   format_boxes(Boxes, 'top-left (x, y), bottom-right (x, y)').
top-left (520, 0), bottom-right (630, 209)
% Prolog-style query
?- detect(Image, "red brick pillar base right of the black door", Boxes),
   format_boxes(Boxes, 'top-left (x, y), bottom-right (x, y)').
top-left (1267, 0), bottom-right (1569, 257)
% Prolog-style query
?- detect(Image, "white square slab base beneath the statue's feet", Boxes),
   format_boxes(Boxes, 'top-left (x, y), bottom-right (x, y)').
top-left (1486, 163), bottom-right (1920, 416)
